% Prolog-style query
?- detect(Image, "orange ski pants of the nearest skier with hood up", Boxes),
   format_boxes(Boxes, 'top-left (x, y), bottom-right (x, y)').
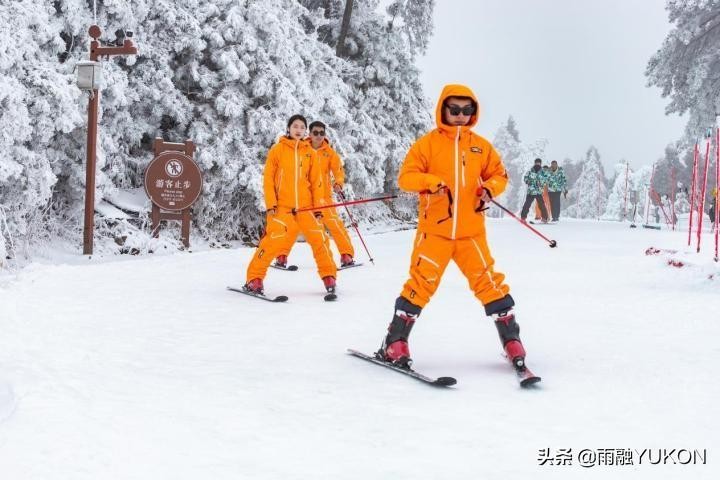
top-left (401, 232), bottom-right (510, 308)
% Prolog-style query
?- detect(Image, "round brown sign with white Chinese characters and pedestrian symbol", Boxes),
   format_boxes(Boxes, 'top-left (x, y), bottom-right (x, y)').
top-left (145, 152), bottom-right (202, 210)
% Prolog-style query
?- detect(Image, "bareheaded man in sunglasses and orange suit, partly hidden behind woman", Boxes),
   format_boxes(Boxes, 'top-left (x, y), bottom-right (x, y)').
top-left (275, 120), bottom-right (355, 268)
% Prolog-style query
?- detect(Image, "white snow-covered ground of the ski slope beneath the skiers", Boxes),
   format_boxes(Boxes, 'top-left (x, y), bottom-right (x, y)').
top-left (0, 219), bottom-right (720, 480)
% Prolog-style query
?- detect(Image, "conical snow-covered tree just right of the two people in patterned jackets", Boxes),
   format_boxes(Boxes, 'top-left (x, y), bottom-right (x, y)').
top-left (566, 146), bottom-right (607, 218)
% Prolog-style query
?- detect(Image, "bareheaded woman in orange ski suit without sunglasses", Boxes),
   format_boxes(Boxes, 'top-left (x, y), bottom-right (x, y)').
top-left (243, 115), bottom-right (337, 294)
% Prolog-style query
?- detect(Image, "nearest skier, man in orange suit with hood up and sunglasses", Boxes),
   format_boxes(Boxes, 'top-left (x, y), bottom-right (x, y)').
top-left (376, 85), bottom-right (525, 368)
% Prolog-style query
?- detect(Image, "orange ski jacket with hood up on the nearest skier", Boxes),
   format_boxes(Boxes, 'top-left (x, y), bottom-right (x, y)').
top-left (398, 85), bottom-right (508, 239)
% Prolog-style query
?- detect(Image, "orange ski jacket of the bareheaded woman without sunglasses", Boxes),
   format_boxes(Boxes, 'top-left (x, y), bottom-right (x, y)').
top-left (263, 136), bottom-right (323, 210)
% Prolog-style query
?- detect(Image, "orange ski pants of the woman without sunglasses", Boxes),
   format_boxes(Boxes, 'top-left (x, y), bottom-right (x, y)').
top-left (247, 208), bottom-right (337, 281)
